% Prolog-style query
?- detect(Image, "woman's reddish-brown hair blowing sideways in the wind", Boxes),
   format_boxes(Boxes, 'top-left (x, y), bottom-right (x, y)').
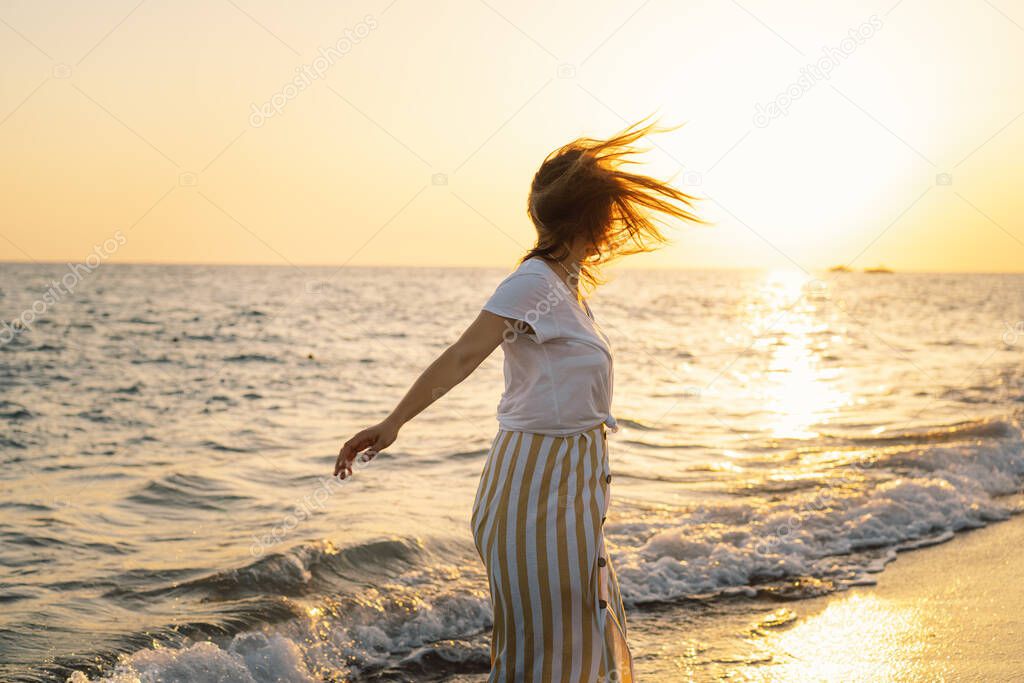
top-left (522, 120), bottom-right (703, 288)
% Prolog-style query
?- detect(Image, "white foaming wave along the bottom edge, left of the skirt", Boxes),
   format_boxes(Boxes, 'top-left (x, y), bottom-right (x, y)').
top-left (68, 595), bottom-right (490, 683)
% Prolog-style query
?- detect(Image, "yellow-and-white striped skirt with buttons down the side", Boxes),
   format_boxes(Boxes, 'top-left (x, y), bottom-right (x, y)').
top-left (472, 425), bottom-right (634, 683)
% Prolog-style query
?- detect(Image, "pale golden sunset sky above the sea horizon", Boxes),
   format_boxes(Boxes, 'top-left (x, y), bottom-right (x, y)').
top-left (0, 0), bottom-right (1024, 271)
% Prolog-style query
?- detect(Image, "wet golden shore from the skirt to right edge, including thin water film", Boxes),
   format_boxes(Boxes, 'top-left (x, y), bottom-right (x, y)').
top-left (637, 509), bottom-right (1024, 682)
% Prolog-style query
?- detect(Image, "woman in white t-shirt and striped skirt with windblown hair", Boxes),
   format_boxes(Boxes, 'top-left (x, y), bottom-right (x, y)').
top-left (335, 124), bottom-right (698, 683)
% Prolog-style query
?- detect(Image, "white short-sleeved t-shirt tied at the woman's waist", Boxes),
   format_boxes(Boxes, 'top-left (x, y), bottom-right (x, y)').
top-left (483, 258), bottom-right (615, 436)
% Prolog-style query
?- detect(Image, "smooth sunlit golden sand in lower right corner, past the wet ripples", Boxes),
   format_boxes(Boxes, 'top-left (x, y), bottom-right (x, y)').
top-left (749, 509), bottom-right (1024, 681)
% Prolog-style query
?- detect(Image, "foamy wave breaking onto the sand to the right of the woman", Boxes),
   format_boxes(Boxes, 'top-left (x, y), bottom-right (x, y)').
top-left (608, 420), bottom-right (1024, 605)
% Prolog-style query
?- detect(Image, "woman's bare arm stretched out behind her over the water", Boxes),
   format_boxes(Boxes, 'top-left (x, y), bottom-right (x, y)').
top-left (334, 311), bottom-right (509, 478)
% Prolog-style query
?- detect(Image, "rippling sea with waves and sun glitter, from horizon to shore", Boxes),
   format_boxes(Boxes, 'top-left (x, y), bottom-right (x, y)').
top-left (0, 264), bottom-right (1024, 682)
